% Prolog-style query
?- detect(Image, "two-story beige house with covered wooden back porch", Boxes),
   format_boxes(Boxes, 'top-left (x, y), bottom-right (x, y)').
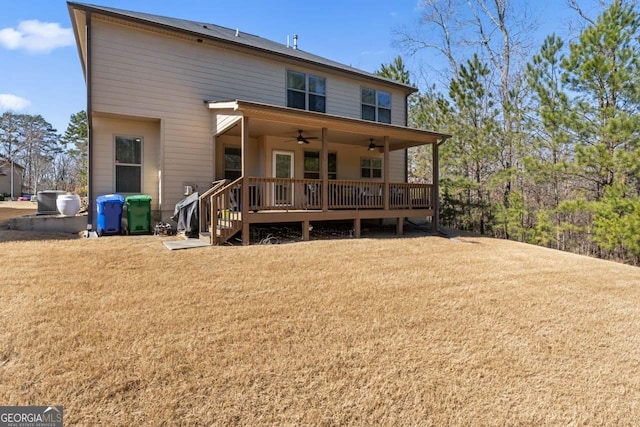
top-left (68, 2), bottom-right (449, 244)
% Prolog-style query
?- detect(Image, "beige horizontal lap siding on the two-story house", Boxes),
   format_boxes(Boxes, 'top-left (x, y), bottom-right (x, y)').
top-left (91, 15), bottom-right (405, 217)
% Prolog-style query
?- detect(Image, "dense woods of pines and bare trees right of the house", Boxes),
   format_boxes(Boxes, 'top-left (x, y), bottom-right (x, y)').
top-left (378, 0), bottom-right (640, 265)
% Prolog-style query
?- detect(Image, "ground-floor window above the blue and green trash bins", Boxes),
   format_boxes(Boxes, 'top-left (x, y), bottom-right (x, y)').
top-left (115, 136), bottom-right (142, 193)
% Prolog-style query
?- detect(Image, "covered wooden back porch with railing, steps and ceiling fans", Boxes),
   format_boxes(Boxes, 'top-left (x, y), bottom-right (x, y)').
top-left (199, 100), bottom-right (449, 244)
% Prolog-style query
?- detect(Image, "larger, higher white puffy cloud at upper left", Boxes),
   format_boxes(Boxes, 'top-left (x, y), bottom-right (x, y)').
top-left (0, 20), bottom-right (74, 53)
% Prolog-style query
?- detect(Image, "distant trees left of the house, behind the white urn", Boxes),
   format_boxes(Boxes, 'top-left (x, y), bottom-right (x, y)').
top-left (0, 111), bottom-right (88, 198)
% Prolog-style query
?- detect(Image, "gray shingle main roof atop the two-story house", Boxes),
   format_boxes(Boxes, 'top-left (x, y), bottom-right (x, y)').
top-left (67, 2), bottom-right (417, 92)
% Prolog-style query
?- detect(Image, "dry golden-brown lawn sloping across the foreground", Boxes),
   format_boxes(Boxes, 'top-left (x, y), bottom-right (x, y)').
top-left (0, 217), bottom-right (640, 426)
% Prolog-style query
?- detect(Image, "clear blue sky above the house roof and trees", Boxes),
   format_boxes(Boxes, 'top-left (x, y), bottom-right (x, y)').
top-left (0, 0), bottom-right (580, 133)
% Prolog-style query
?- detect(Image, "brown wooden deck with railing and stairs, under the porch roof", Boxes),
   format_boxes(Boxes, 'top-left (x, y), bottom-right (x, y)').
top-left (200, 177), bottom-right (434, 244)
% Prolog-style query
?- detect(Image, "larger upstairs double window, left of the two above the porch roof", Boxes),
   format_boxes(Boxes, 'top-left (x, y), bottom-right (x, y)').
top-left (287, 70), bottom-right (327, 113)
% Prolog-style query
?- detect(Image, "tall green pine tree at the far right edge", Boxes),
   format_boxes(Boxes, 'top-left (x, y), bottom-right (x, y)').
top-left (562, 0), bottom-right (640, 200)
